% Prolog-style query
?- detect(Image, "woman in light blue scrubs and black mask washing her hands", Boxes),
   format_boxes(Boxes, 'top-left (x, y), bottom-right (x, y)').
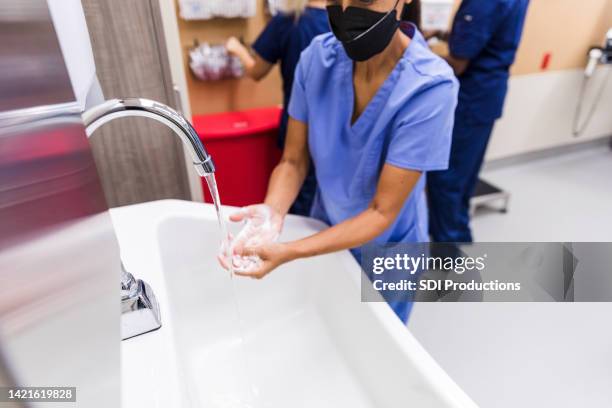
top-left (222, 0), bottom-right (458, 321)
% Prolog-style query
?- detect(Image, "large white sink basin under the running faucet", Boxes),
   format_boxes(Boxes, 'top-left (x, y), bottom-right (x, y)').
top-left (111, 200), bottom-right (476, 408)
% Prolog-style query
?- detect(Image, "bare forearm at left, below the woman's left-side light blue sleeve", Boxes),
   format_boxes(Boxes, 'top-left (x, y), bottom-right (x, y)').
top-left (264, 159), bottom-right (309, 216)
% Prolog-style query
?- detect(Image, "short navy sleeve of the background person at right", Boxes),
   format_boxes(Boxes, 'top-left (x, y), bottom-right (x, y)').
top-left (449, 0), bottom-right (506, 59)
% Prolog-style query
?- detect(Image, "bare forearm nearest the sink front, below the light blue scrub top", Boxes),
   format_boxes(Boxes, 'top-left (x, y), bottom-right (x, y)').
top-left (287, 207), bottom-right (395, 259)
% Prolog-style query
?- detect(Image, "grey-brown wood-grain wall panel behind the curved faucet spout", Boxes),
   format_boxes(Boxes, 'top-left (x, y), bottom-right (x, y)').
top-left (83, 0), bottom-right (190, 207)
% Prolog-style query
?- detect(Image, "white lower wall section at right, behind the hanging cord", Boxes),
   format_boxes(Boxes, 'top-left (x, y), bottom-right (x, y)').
top-left (487, 67), bottom-right (612, 160)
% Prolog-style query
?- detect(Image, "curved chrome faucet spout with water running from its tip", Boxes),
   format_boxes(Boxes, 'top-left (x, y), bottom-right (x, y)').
top-left (82, 98), bottom-right (215, 176)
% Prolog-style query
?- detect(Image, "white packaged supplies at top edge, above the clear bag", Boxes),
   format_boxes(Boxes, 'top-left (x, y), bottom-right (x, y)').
top-left (179, 0), bottom-right (257, 20)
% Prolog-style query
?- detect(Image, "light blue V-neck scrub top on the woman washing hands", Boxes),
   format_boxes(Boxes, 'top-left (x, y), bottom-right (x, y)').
top-left (289, 23), bottom-right (458, 259)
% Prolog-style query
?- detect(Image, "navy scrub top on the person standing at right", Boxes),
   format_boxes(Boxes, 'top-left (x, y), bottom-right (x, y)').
top-left (449, 0), bottom-right (529, 123)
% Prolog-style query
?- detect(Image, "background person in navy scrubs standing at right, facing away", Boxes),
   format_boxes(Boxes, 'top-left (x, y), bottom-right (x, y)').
top-left (427, 0), bottom-right (529, 242)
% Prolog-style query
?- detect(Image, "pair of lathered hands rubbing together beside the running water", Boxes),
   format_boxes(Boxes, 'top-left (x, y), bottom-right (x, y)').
top-left (219, 204), bottom-right (283, 278)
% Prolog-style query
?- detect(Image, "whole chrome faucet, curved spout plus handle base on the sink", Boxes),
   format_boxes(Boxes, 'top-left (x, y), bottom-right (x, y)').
top-left (82, 98), bottom-right (215, 340)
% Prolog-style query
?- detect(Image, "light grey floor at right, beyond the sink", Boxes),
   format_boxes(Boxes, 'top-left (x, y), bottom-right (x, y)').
top-left (408, 147), bottom-right (612, 408)
